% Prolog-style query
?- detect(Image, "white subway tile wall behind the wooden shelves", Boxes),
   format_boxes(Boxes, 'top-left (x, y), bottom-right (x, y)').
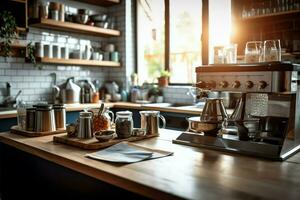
top-left (0, 0), bottom-right (135, 103)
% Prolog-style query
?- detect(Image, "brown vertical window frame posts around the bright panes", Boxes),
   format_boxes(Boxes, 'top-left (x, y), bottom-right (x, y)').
top-left (135, 0), bottom-right (209, 86)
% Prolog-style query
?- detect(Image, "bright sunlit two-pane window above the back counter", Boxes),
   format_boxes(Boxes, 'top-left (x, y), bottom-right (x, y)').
top-left (137, 0), bottom-right (202, 84)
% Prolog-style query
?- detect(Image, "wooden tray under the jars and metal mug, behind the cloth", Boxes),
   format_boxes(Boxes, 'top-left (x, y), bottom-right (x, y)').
top-left (53, 135), bottom-right (157, 150)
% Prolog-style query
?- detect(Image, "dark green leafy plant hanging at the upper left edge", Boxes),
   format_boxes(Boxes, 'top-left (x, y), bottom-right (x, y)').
top-left (0, 11), bottom-right (17, 57)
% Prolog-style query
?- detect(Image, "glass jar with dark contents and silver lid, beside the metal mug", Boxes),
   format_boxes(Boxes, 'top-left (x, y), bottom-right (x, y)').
top-left (116, 111), bottom-right (133, 138)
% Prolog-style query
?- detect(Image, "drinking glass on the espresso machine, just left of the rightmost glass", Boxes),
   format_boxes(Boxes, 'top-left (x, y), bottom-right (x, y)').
top-left (245, 41), bottom-right (263, 63)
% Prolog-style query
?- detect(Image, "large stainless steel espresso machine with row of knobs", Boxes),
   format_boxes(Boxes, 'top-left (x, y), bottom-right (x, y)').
top-left (173, 62), bottom-right (300, 160)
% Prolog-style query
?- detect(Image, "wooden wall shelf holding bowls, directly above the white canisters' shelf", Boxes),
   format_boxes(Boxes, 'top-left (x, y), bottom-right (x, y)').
top-left (29, 19), bottom-right (121, 37)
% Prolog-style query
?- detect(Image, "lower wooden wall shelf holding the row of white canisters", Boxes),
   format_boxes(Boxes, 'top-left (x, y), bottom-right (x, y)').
top-left (26, 58), bottom-right (121, 67)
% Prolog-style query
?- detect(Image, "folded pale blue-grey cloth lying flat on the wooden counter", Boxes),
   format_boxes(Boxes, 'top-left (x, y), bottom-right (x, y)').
top-left (86, 142), bottom-right (173, 163)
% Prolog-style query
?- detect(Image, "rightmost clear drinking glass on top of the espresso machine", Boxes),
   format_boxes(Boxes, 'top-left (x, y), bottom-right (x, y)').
top-left (264, 40), bottom-right (281, 62)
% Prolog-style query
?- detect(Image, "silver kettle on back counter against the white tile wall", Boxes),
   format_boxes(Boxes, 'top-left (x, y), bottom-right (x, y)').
top-left (59, 77), bottom-right (80, 103)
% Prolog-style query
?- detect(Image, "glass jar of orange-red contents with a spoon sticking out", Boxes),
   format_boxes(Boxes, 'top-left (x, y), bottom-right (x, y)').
top-left (92, 108), bottom-right (115, 132)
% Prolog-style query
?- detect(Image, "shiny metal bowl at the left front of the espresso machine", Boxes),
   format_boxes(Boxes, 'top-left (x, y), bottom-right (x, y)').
top-left (188, 117), bottom-right (222, 136)
